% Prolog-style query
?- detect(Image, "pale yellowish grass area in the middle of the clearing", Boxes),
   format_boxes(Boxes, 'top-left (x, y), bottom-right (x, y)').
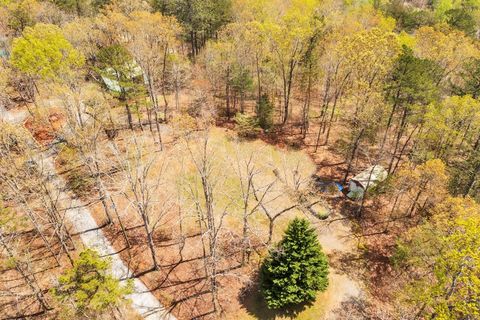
top-left (112, 129), bottom-right (315, 242)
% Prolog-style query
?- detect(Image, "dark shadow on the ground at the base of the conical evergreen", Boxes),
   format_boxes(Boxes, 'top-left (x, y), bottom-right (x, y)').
top-left (238, 275), bottom-right (313, 320)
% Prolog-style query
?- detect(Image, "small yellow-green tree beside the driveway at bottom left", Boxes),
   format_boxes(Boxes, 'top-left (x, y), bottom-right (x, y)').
top-left (53, 249), bottom-right (132, 316)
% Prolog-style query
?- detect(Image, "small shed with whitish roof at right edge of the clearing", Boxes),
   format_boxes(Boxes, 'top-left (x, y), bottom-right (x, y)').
top-left (347, 165), bottom-right (388, 200)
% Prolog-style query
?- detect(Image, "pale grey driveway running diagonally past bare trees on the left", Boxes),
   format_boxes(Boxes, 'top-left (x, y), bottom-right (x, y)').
top-left (0, 110), bottom-right (176, 320)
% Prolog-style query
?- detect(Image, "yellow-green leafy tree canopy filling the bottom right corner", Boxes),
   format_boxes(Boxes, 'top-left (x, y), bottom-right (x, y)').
top-left (399, 198), bottom-right (480, 319)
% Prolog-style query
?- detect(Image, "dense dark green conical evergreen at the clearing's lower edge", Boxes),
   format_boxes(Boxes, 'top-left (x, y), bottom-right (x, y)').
top-left (261, 218), bottom-right (328, 309)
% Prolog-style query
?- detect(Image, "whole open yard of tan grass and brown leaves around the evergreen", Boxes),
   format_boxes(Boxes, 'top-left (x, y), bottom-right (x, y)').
top-left (49, 117), bottom-right (362, 319)
